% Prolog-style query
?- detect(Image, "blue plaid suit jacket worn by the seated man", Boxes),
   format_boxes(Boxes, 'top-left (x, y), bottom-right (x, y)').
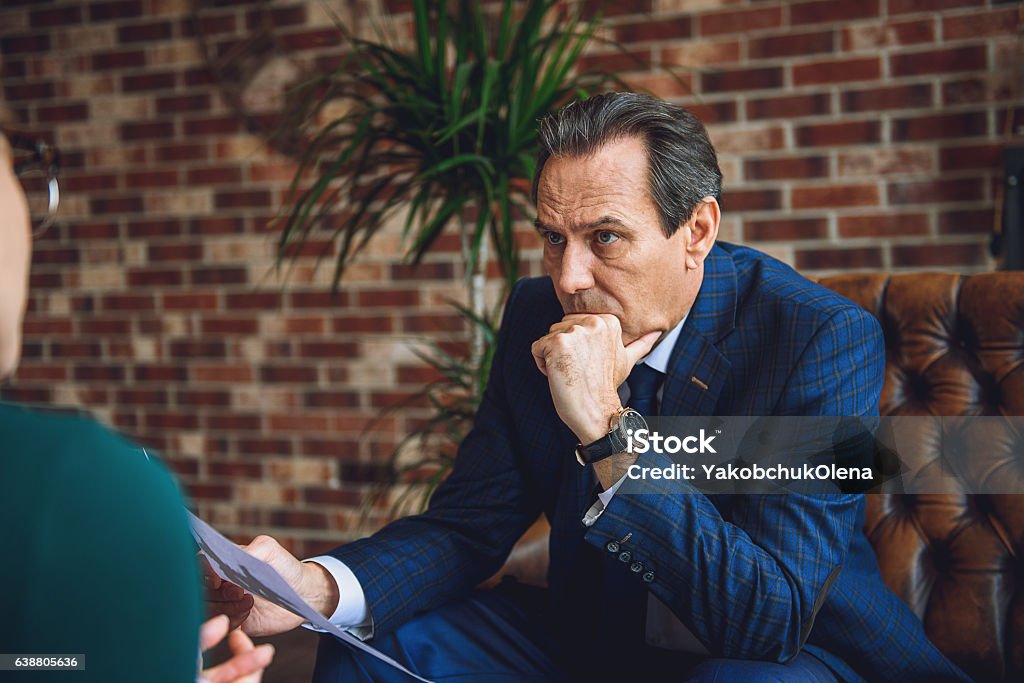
top-left (333, 243), bottom-right (965, 681)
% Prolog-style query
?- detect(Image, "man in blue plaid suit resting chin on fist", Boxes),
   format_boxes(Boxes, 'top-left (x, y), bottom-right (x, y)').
top-left (212, 93), bottom-right (965, 683)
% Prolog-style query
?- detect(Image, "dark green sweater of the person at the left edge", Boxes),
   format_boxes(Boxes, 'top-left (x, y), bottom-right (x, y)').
top-left (0, 407), bottom-right (202, 683)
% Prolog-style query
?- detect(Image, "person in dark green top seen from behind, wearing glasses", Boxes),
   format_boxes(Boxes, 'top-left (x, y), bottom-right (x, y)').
top-left (0, 108), bottom-right (273, 683)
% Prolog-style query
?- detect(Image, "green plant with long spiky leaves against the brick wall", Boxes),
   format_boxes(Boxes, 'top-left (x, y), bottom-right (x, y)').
top-left (280, 0), bottom-right (634, 507)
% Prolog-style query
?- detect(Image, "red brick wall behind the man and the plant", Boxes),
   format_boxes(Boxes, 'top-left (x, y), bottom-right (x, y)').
top-left (0, 0), bottom-right (1021, 553)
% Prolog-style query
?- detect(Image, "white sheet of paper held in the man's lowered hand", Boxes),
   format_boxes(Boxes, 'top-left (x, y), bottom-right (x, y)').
top-left (188, 512), bottom-right (431, 683)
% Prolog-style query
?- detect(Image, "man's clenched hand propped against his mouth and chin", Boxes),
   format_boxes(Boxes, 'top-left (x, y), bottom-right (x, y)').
top-left (530, 313), bottom-right (662, 443)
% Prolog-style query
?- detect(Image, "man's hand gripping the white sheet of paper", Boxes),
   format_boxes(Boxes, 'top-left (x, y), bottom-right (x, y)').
top-left (202, 536), bottom-right (339, 636)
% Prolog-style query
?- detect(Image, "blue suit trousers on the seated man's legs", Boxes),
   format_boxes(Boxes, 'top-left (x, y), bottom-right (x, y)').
top-left (312, 583), bottom-right (838, 683)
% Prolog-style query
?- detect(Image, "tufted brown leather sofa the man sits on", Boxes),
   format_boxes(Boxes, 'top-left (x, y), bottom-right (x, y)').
top-left (500, 272), bottom-right (1024, 682)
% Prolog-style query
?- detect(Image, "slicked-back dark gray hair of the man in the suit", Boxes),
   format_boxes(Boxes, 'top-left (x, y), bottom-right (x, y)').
top-left (530, 92), bottom-right (722, 237)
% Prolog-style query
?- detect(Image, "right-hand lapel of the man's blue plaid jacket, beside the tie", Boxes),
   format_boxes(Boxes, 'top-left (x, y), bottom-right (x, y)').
top-left (659, 245), bottom-right (737, 416)
